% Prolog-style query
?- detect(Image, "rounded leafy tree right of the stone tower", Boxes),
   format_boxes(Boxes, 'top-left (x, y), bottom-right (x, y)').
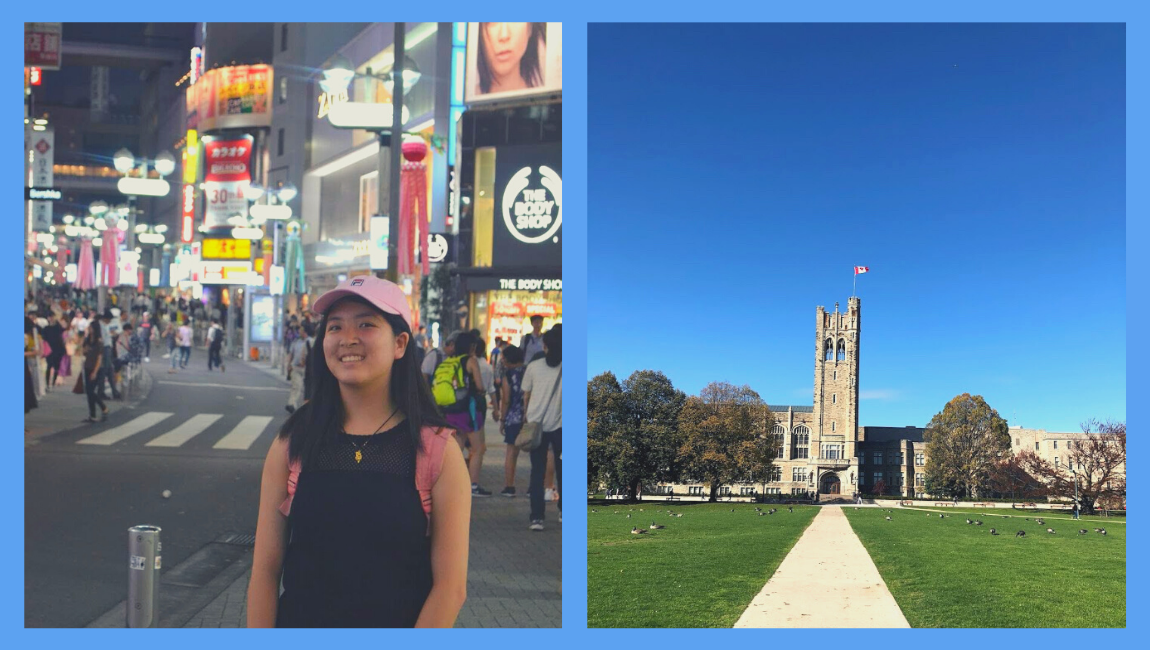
top-left (923, 392), bottom-right (1010, 497)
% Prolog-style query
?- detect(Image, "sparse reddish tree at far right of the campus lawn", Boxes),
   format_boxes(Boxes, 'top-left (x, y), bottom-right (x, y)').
top-left (1019, 420), bottom-right (1126, 514)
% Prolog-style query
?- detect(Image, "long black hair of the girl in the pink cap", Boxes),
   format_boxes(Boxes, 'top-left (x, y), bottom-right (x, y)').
top-left (279, 297), bottom-right (447, 466)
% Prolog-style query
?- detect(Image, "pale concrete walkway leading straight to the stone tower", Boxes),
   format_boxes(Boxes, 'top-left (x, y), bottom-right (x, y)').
top-left (735, 506), bottom-right (910, 628)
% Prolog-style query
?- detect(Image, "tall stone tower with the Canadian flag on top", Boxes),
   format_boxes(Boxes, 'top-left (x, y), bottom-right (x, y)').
top-left (811, 297), bottom-right (863, 496)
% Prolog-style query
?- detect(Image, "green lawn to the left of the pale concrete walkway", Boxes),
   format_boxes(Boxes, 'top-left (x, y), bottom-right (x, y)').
top-left (587, 502), bottom-right (818, 627)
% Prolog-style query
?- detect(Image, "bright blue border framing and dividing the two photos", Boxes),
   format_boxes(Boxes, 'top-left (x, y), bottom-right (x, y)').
top-left (0, 0), bottom-right (1150, 650)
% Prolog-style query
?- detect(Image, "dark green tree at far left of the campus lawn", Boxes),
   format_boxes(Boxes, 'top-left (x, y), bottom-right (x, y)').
top-left (588, 370), bottom-right (685, 499)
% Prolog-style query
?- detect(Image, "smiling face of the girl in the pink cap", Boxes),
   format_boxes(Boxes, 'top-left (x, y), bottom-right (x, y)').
top-left (323, 300), bottom-right (409, 385)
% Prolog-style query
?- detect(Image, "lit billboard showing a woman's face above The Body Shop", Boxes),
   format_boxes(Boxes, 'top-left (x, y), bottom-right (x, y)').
top-left (463, 23), bottom-right (564, 104)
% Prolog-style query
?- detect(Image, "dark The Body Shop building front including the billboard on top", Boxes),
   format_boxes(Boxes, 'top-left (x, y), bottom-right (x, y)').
top-left (455, 23), bottom-right (564, 346)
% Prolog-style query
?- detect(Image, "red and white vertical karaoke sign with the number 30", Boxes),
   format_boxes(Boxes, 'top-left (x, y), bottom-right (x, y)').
top-left (204, 136), bottom-right (252, 228)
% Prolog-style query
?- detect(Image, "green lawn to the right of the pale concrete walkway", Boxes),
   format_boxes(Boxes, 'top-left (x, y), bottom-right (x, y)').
top-left (845, 507), bottom-right (1126, 627)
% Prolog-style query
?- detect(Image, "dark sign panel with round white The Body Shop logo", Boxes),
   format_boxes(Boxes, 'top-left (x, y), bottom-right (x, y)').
top-left (492, 144), bottom-right (564, 268)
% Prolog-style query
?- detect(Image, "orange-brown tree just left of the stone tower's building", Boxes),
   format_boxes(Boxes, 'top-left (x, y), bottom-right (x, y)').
top-left (679, 382), bottom-right (775, 502)
